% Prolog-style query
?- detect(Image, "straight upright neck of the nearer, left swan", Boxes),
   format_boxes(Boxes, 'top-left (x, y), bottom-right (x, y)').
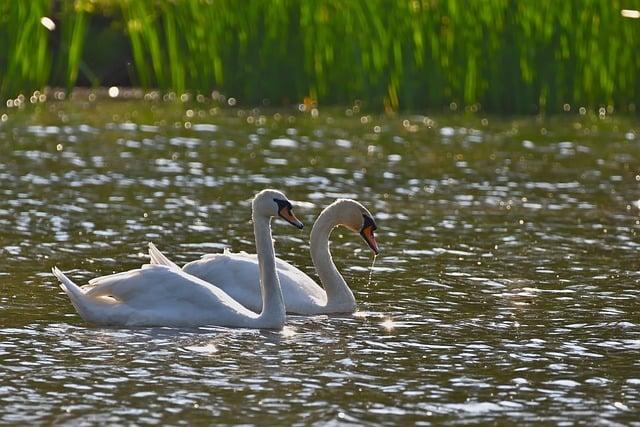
top-left (253, 216), bottom-right (286, 327)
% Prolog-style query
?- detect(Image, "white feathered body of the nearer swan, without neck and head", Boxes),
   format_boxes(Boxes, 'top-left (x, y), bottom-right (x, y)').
top-left (54, 265), bottom-right (257, 327)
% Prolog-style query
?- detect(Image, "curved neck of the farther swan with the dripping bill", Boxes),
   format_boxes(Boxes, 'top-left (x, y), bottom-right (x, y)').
top-left (310, 205), bottom-right (356, 312)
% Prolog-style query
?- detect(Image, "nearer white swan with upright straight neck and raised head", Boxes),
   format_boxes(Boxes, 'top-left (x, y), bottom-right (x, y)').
top-left (53, 190), bottom-right (302, 329)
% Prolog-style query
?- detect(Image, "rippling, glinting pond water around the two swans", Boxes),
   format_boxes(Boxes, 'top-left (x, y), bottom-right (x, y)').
top-left (0, 101), bottom-right (640, 425)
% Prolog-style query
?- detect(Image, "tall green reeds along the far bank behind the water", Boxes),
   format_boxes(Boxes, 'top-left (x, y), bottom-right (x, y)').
top-left (0, 0), bottom-right (640, 113)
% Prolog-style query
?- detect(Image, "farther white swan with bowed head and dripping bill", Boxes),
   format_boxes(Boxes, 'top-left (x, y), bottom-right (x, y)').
top-left (149, 199), bottom-right (379, 315)
